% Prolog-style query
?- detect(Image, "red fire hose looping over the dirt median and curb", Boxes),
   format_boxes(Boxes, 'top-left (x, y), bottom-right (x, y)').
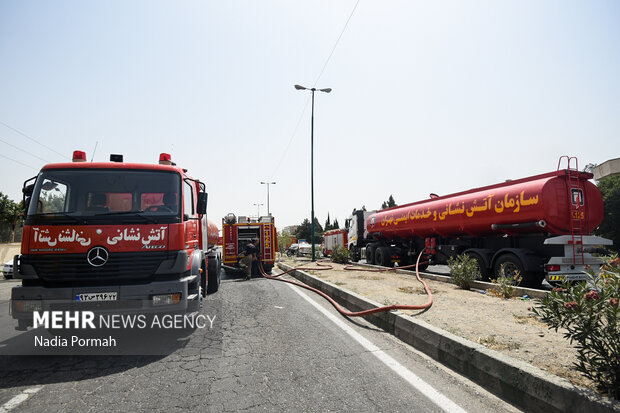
top-left (258, 249), bottom-right (433, 317)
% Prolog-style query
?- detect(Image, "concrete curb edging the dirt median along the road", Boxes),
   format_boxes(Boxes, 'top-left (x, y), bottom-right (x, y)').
top-left (277, 263), bottom-right (620, 413)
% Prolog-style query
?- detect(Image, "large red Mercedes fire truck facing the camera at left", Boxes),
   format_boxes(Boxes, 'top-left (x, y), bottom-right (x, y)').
top-left (11, 151), bottom-right (221, 330)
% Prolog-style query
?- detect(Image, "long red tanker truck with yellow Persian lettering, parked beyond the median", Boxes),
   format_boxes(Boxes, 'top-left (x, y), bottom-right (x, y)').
top-left (348, 158), bottom-right (612, 287)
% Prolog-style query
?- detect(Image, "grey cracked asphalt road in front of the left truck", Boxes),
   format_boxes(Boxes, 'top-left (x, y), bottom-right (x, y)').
top-left (0, 268), bottom-right (517, 413)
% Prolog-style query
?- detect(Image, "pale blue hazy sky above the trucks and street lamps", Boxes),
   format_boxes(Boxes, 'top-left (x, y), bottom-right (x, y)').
top-left (0, 0), bottom-right (620, 227)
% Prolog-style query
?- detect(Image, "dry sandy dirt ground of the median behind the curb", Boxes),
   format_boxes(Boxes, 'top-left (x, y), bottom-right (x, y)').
top-left (283, 258), bottom-right (594, 389)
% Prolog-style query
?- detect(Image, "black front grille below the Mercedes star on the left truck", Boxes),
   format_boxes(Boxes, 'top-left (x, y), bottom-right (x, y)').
top-left (20, 252), bottom-right (170, 281)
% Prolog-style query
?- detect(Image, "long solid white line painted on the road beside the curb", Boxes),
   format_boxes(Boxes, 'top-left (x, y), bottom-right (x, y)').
top-left (287, 284), bottom-right (466, 413)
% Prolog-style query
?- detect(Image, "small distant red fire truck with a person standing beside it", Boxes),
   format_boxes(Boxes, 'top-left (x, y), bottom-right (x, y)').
top-left (222, 214), bottom-right (278, 273)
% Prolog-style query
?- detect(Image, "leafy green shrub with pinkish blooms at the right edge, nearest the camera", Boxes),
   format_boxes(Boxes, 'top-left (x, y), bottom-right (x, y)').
top-left (533, 260), bottom-right (620, 400)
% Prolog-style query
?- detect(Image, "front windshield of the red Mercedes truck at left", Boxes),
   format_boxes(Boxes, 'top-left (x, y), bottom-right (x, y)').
top-left (27, 169), bottom-right (182, 223)
